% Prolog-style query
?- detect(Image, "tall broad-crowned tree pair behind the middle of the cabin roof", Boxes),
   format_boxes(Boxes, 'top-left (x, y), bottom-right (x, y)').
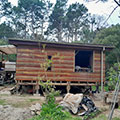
top-left (46, 0), bottom-right (88, 42)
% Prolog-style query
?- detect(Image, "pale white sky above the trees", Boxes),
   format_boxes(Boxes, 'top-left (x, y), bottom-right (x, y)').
top-left (8, 0), bottom-right (120, 25)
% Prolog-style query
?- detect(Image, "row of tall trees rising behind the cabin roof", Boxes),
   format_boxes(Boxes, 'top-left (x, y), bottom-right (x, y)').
top-left (0, 0), bottom-right (109, 43)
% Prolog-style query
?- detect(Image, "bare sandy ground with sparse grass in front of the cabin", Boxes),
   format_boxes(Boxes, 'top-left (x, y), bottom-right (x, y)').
top-left (0, 86), bottom-right (120, 120)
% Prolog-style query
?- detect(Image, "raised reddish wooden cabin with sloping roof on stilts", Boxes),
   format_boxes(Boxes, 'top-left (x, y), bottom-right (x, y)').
top-left (9, 39), bottom-right (113, 92)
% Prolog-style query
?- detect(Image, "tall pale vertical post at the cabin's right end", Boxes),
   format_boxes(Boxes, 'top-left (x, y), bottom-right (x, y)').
top-left (101, 47), bottom-right (105, 93)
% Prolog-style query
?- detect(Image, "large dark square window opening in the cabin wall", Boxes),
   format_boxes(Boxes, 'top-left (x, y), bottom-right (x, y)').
top-left (75, 50), bottom-right (93, 72)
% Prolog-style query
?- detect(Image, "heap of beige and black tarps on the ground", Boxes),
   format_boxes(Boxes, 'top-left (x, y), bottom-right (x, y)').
top-left (60, 93), bottom-right (97, 115)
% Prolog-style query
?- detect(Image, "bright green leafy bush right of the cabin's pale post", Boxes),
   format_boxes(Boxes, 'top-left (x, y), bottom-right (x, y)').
top-left (107, 63), bottom-right (120, 90)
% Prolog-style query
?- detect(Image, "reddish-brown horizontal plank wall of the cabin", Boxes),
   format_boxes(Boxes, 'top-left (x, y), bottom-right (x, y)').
top-left (16, 46), bottom-right (105, 82)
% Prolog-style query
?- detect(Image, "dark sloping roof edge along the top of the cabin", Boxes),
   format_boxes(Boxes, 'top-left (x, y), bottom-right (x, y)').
top-left (9, 39), bottom-right (114, 50)
